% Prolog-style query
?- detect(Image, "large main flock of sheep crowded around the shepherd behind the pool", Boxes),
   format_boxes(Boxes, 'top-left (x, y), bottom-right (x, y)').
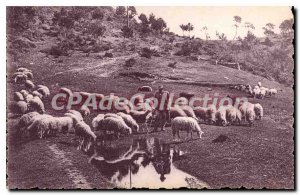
top-left (8, 68), bottom-right (263, 155)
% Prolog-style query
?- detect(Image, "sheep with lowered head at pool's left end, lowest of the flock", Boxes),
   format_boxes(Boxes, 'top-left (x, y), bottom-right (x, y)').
top-left (75, 121), bottom-right (97, 152)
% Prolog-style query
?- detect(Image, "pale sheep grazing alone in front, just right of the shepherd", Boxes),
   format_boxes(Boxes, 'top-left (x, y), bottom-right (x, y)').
top-left (171, 117), bottom-right (203, 139)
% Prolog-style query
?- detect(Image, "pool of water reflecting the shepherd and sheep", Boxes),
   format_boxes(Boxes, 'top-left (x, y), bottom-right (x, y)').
top-left (91, 138), bottom-right (208, 188)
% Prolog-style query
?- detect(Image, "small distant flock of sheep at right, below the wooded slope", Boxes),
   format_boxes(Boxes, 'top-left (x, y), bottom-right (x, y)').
top-left (233, 82), bottom-right (277, 99)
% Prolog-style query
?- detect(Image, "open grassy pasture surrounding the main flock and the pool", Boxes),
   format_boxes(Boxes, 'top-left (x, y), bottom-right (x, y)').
top-left (7, 32), bottom-right (294, 189)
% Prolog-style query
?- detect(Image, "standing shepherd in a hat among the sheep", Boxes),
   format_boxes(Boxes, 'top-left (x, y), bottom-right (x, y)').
top-left (154, 85), bottom-right (170, 131)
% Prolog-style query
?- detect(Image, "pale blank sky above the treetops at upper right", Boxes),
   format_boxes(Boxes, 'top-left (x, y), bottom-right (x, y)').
top-left (136, 6), bottom-right (293, 40)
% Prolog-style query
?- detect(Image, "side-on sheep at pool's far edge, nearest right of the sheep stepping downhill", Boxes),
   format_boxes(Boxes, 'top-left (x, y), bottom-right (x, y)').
top-left (99, 117), bottom-right (132, 138)
